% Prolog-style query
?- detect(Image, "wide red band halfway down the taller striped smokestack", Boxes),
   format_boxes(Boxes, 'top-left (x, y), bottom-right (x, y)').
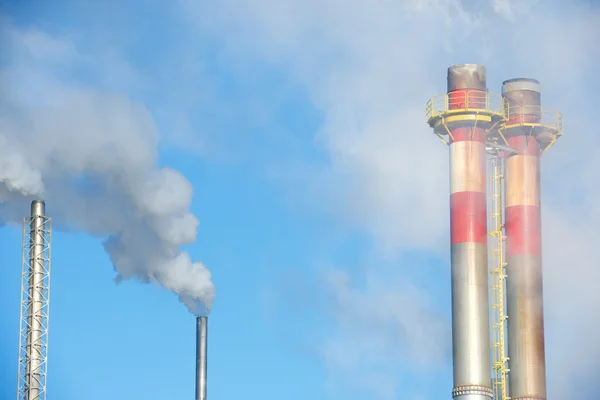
top-left (450, 192), bottom-right (487, 244)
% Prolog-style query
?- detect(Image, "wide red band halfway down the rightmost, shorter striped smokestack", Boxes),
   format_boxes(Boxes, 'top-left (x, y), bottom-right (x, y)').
top-left (505, 206), bottom-right (542, 257)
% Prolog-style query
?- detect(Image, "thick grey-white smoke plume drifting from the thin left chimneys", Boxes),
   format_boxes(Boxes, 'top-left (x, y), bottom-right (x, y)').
top-left (0, 20), bottom-right (215, 314)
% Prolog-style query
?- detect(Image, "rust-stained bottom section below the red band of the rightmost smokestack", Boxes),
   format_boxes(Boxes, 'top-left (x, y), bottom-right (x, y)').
top-left (506, 255), bottom-right (546, 399)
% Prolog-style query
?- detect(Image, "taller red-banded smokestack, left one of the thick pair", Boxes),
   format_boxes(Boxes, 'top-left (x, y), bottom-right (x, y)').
top-left (448, 64), bottom-right (493, 400)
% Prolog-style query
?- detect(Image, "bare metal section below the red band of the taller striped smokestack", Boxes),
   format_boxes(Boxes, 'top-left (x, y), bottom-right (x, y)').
top-left (451, 243), bottom-right (491, 392)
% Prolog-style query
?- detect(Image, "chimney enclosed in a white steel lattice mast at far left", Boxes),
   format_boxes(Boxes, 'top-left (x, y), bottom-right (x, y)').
top-left (17, 200), bottom-right (52, 400)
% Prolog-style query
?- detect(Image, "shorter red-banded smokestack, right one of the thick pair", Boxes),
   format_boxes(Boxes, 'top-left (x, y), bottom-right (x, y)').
top-left (502, 79), bottom-right (546, 400)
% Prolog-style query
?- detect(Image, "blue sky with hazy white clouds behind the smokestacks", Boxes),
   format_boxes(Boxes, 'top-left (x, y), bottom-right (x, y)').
top-left (0, 0), bottom-right (600, 400)
